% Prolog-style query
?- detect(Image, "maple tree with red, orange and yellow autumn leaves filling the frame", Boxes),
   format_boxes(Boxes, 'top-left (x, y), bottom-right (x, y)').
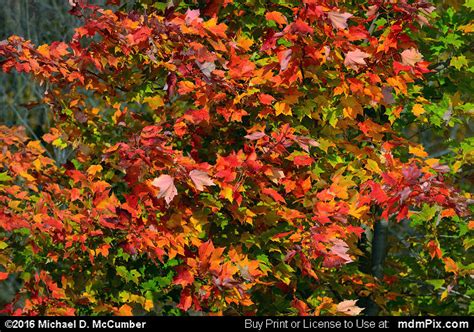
top-left (0, 0), bottom-right (473, 315)
